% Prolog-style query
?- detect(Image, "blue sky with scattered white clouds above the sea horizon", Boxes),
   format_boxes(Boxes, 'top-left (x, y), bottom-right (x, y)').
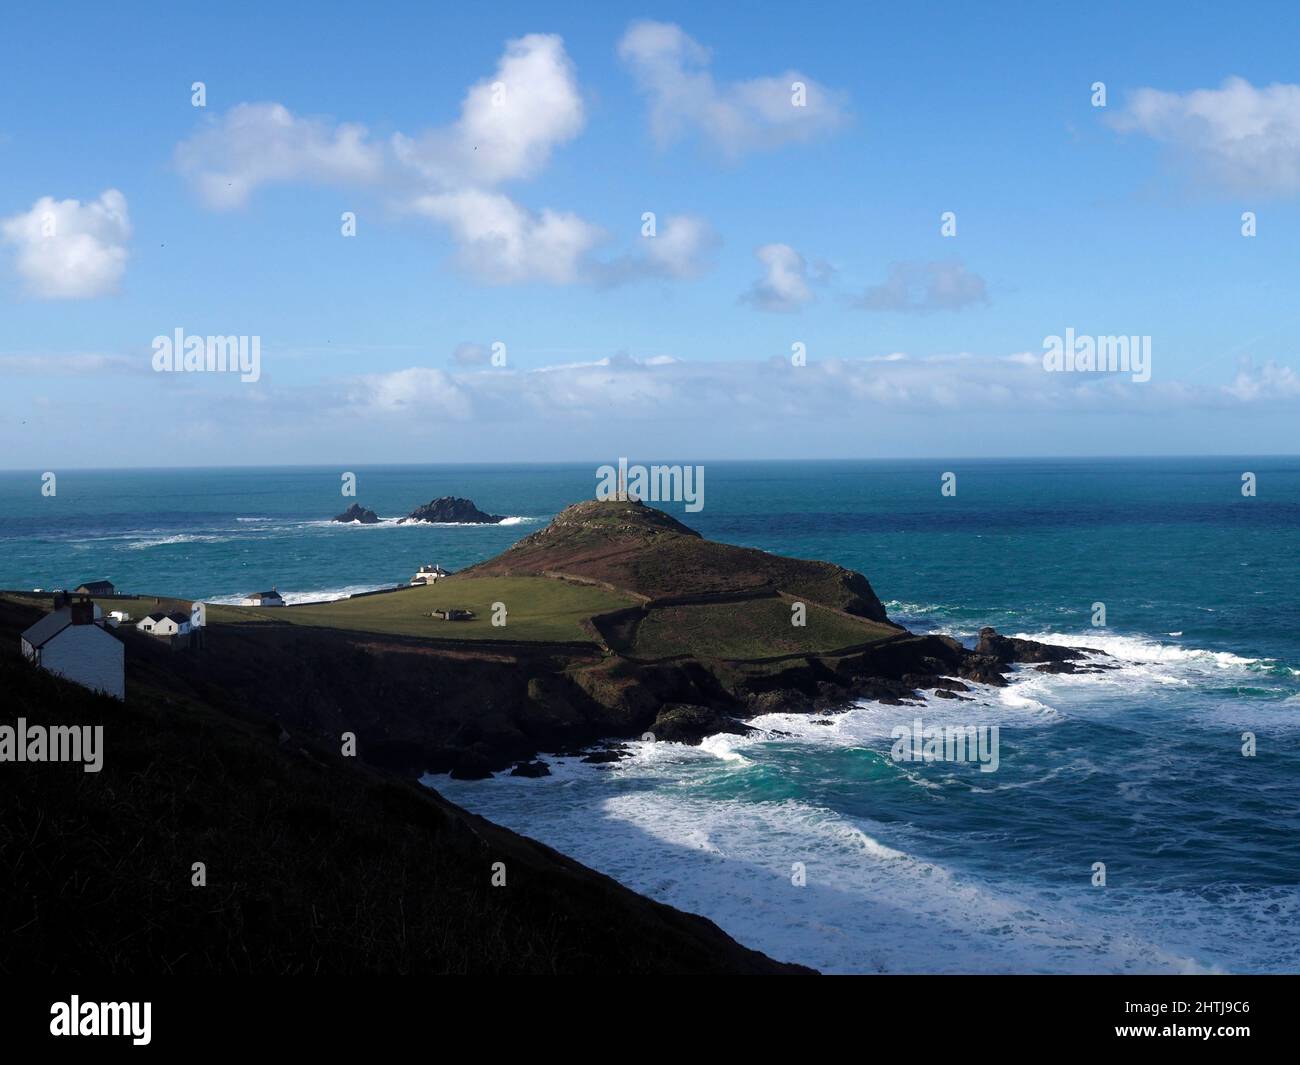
top-left (0, 3), bottom-right (1300, 469)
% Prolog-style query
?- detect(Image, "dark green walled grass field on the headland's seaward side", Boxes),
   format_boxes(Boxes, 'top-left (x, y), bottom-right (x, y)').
top-left (632, 597), bottom-right (898, 658)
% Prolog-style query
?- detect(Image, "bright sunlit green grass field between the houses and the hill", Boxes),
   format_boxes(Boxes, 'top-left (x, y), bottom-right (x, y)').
top-left (208, 577), bottom-right (633, 641)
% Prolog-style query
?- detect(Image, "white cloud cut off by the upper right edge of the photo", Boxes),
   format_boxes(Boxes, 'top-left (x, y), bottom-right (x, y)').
top-left (1112, 78), bottom-right (1300, 194)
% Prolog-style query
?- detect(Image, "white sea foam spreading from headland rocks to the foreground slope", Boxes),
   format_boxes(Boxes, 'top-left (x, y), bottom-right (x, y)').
top-left (429, 631), bottom-right (1300, 973)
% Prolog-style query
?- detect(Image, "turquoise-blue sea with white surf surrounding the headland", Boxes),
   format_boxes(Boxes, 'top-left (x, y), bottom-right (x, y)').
top-left (0, 458), bottom-right (1300, 973)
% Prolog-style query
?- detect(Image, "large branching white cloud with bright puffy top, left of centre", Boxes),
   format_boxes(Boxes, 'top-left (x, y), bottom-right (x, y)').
top-left (176, 34), bottom-right (716, 285)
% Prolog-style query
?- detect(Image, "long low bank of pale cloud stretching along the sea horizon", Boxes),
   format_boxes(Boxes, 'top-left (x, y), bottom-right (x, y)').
top-left (12, 346), bottom-right (1300, 468)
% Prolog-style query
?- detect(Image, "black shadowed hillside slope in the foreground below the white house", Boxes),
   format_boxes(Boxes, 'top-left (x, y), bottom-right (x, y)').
top-left (0, 603), bottom-right (792, 975)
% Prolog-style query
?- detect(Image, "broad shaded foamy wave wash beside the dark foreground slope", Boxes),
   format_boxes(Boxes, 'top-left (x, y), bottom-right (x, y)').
top-left (438, 764), bottom-right (1279, 973)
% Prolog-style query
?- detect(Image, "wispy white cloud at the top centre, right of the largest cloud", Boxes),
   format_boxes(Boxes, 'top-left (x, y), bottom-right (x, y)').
top-left (619, 21), bottom-right (848, 159)
